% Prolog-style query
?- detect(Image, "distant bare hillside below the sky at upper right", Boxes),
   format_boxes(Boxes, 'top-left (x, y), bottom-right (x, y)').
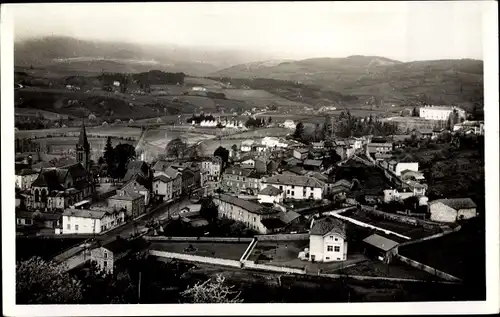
top-left (210, 56), bottom-right (483, 103)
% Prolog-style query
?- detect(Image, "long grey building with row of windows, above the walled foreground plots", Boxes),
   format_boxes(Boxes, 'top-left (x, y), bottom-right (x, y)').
top-left (214, 194), bottom-right (280, 234)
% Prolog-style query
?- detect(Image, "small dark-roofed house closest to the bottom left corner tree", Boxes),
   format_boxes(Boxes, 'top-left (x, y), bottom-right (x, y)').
top-left (90, 236), bottom-right (148, 274)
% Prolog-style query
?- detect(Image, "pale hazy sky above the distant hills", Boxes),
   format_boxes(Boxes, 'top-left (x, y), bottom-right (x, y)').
top-left (8, 1), bottom-right (484, 61)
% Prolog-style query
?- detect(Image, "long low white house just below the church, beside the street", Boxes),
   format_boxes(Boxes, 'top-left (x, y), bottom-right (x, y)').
top-left (62, 206), bottom-right (125, 234)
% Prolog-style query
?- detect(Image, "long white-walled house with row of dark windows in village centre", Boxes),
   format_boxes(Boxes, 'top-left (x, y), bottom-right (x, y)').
top-left (262, 175), bottom-right (326, 200)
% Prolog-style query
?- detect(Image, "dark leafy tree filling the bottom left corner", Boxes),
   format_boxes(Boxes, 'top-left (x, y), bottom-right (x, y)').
top-left (16, 257), bottom-right (82, 304)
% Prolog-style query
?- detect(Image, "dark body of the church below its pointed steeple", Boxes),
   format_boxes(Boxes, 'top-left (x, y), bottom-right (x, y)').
top-left (26, 163), bottom-right (95, 210)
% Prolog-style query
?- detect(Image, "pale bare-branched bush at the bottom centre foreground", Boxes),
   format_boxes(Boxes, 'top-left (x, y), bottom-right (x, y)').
top-left (181, 274), bottom-right (243, 303)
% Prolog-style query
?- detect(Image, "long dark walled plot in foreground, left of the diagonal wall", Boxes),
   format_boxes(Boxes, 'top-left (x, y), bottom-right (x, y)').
top-left (149, 242), bottom-right (248, 260)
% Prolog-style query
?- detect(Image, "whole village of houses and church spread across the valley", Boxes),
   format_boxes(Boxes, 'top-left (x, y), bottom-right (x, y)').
top-left (16, 100), bottom-right (484, 302)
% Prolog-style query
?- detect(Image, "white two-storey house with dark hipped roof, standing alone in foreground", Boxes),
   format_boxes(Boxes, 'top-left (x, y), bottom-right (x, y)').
top-left (309, 217), bottom-right (347, 262)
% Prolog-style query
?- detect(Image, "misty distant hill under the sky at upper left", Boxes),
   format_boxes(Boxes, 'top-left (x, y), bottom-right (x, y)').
top-left (14, 36), bottom-right (280, 76)
